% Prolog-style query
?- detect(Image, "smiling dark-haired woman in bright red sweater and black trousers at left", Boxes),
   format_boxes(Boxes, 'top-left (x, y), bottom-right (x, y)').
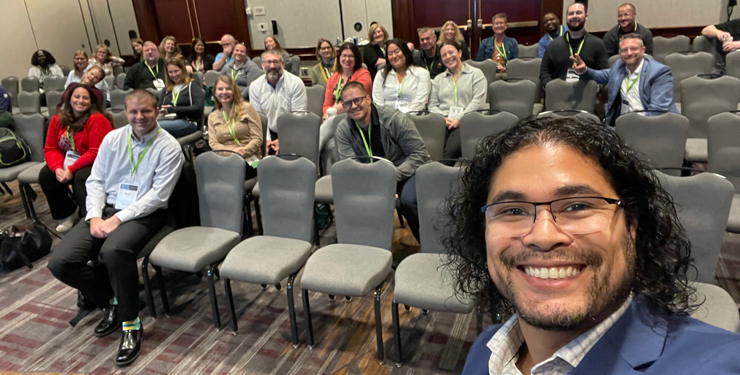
top-left (39, 84), bottom-right (113, 233)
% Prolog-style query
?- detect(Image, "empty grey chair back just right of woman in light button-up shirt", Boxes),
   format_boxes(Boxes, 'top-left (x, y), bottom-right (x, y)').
top-left (488, 80), bottom-right (542, 120)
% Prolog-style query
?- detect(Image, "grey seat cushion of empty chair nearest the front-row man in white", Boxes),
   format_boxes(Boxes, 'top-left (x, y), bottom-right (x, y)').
top-left (149, 227), bottom-right (239, 272)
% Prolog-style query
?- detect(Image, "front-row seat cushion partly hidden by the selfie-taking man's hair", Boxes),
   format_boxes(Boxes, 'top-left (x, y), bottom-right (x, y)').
top-left (393, 253), bottom-right (473, 314)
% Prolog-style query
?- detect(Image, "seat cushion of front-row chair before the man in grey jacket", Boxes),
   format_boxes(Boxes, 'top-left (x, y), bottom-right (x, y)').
top-left (301, 244), bottom-right (393, 297)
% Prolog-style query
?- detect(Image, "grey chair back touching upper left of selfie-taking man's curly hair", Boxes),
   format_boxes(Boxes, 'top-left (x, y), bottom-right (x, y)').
top-left (460, 112), bottom-right (519, 160)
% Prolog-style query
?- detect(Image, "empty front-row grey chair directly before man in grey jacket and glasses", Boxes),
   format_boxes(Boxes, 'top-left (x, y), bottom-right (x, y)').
top-left (301, 158), bottom-right (396, 362)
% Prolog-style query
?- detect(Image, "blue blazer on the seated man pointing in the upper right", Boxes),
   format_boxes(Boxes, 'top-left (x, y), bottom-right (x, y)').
top-left (586, 56), bottom-right (679, 126)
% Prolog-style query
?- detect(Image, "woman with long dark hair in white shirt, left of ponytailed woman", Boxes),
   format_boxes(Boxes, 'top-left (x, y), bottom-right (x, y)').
top-left (373, 39), bottom-right (432, 113)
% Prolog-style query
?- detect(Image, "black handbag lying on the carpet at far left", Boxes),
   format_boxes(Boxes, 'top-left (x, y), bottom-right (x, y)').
top-left (0, 220), bottom-right (51, 272)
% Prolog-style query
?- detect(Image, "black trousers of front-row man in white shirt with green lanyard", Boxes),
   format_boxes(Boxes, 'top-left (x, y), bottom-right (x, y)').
top-left (48, 206), bottom-right (166, 321)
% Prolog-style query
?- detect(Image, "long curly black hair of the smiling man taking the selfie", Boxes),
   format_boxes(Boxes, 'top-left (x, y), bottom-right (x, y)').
top-left (443, 117), bottom-right (695, 315)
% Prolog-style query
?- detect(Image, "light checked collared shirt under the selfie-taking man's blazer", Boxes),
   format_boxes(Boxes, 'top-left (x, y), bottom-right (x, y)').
top-left (486, 294), bottom-right (633, 375)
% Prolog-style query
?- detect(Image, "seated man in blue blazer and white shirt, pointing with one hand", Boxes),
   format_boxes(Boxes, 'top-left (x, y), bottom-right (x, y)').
top-left (571, 34), bottom-right (679, 126)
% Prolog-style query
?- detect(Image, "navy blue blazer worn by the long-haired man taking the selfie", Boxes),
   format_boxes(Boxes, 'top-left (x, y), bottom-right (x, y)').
top-left (463, 296), bottom-right (740, 375)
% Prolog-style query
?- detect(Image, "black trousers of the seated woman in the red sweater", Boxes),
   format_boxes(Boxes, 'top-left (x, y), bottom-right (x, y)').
top-left (39, 165), bottom-right (92, 220)
